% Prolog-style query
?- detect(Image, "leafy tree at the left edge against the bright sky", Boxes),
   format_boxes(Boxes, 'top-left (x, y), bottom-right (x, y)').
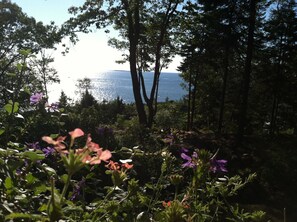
top-left (0, 0), bottom-right (62, 103)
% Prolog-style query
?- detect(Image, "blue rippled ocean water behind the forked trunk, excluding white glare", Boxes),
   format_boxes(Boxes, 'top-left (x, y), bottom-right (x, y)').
top-left (90, 71), bottom-right (186, 103)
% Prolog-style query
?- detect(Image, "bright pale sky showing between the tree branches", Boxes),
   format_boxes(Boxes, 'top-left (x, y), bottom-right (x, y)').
top-left (11, 0), bottom-right (180, 78)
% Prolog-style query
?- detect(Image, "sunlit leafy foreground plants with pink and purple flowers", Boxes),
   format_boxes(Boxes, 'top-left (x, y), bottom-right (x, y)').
top-left (0, 88), bottom-right (265, 221)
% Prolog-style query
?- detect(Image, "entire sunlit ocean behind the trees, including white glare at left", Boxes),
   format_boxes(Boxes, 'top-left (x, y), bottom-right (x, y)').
top-left (49, 70), bottom-right (186, 103)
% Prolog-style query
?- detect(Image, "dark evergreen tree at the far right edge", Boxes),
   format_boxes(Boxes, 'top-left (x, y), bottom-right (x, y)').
top-left (265, 0), bottom-right (297, 134)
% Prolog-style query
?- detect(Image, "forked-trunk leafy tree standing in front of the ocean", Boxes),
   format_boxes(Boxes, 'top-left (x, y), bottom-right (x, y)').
top-left (64, 0), bottom-right (181, 127)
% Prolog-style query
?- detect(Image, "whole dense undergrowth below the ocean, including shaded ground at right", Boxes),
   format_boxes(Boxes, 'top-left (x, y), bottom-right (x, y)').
top-left (0, 91), bottom-right (297, 221)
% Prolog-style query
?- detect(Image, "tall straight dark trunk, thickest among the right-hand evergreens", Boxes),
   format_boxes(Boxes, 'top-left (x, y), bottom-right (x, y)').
top-left (237, 0), bottom-right (257, 142)
